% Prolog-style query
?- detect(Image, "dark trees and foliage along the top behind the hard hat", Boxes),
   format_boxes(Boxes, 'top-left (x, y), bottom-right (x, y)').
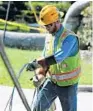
top-left (0, 1), bottom-right (73, 24)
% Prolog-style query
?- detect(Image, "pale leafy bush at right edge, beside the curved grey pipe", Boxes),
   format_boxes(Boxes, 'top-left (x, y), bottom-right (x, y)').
top-left (77, 2), bottom-right (92, 50)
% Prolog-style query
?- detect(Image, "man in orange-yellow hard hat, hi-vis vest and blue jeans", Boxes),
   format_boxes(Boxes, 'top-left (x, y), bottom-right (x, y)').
top-left (27, 5), bottom-right (80, 111)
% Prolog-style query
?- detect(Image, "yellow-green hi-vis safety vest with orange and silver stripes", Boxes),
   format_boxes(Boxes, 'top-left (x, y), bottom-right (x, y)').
top-left (46, 29), bottom-right (81, 86)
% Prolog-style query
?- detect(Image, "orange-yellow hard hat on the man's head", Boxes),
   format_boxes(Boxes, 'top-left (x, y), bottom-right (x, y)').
top-left (39, 5), bottom-right (59, 25)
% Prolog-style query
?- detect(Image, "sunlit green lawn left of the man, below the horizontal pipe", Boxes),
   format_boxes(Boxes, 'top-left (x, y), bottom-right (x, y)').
top-left (0, 48), bottom-right (41, 88)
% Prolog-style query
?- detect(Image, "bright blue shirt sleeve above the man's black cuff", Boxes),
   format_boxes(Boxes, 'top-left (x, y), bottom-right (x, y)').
top-left (54, 35), bottom-right (79, 63)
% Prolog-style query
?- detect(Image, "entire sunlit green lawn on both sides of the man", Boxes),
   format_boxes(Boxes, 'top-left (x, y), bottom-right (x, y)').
top-left (0, 48), bottom-right (92, 88)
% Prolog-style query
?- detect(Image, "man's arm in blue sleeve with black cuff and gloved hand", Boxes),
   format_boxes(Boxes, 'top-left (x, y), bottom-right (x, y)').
top-left (27, 36), bottom-right (78, 70)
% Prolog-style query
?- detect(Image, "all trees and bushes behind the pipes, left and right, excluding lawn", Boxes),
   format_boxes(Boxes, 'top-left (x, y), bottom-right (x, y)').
top-left (0, 1), bottom-right (92, 50)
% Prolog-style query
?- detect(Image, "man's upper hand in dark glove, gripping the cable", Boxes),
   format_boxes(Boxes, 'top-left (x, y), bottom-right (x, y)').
top-left (26, 60), bottom-right (41, 71)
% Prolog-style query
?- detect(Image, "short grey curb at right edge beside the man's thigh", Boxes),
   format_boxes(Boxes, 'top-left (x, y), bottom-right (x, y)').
top-left (78, 85), bottom-right (93, 92)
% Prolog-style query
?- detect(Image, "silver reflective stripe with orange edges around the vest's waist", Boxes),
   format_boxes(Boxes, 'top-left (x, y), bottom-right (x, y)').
top-left (51, 67), bottom-right (81, 81)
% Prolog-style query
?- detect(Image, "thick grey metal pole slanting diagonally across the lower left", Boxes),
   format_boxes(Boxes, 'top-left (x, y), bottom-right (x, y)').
top-left (0, 37), bottom-right (31, 111)
